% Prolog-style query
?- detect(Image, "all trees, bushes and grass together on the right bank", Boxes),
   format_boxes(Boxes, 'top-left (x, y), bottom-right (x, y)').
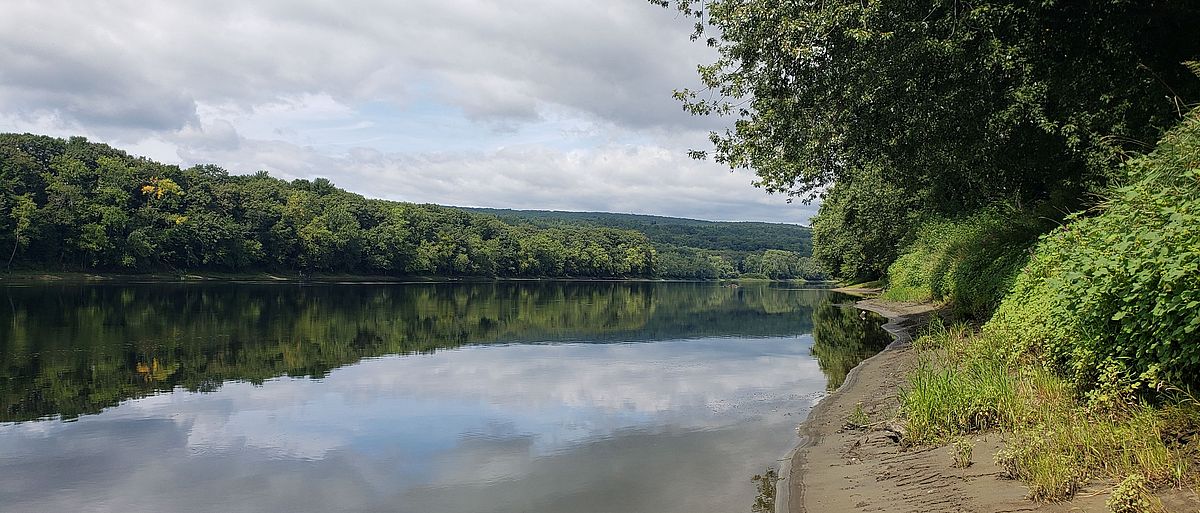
top-left (649, 0), bottom-right (1200, 505)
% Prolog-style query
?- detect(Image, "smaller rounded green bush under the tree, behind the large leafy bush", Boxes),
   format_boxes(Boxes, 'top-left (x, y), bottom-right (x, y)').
top-left (883, 211), bottom-right (1044, 319)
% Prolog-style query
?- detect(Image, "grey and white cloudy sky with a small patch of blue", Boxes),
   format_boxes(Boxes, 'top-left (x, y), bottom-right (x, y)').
top-left (0, 0), bottom-right (815, 224)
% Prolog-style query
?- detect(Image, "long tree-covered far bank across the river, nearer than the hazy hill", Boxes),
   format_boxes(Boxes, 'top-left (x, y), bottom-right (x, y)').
top-left (0, 134), bottom-right (821, 279)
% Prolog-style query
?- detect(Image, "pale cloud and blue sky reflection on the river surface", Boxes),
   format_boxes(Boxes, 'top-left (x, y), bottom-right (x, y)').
top-left (0, 336), bottom-right (826, 513)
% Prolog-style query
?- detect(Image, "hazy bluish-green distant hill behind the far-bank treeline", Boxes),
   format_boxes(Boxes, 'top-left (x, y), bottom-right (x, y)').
top-left (463, 209), bottom-right (812, 257)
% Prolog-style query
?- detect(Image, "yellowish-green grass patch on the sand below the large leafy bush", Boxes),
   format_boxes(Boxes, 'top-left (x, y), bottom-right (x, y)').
top-left (900, 326), bottom-right (1200, 501)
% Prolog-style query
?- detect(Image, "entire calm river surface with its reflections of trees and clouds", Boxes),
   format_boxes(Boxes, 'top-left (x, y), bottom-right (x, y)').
top-left (0, 283), bottom-right (888, 513)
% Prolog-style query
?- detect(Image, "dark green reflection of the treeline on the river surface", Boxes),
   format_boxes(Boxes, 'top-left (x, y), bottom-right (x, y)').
top-left (0, 282), bottom-right (878, 422)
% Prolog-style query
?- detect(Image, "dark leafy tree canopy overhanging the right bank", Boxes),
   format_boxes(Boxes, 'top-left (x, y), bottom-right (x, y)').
top-left (650, 0), bottom-right (1200, 212)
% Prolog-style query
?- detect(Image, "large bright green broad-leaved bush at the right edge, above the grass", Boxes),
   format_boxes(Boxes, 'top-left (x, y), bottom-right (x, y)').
top-left (985, 111), bottom-right (1200, 402)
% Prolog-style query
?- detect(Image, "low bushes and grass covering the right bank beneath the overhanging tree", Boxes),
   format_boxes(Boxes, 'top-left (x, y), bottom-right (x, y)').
top-left (886, 107), bottom-right (1200, 501)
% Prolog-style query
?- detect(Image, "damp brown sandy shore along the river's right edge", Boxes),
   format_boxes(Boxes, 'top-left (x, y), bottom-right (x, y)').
top-left (778, 300), bottom-right (1108, 513)
